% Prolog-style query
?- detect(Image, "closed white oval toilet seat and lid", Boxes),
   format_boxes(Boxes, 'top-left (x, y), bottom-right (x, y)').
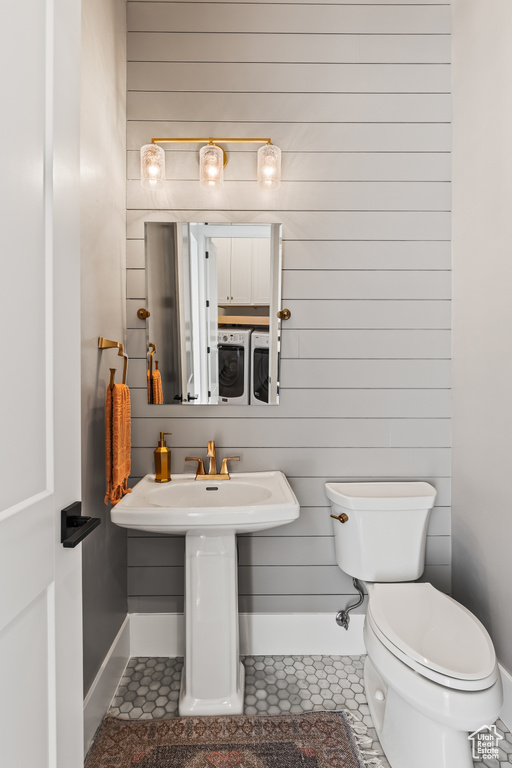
top-left (367, 583), bottom-right (497, 691)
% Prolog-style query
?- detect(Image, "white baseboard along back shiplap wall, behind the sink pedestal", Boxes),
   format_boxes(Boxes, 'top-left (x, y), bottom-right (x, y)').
top-left (130, 613), bottom-right (365, 656)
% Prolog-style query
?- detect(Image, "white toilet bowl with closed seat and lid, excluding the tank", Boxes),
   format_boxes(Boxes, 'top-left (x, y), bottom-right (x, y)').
top-left (364, 583), bottom-right (503, 768)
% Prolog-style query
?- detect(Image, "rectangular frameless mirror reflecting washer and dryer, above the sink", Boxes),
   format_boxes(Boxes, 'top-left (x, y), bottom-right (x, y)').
top-left (145, 222), bottom-right (281, 406)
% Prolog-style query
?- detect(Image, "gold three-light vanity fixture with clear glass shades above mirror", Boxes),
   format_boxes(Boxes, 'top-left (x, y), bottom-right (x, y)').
top-left (140, 138), bottom-right (281, 189)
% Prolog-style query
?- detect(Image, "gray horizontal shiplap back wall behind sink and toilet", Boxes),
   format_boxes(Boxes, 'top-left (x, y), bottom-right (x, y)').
top-left (127, 0), bottom-right (451, 612)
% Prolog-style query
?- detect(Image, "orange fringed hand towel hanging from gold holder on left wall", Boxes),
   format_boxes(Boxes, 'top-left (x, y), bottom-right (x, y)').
top-left (105, 384), bottom-right (131, 504)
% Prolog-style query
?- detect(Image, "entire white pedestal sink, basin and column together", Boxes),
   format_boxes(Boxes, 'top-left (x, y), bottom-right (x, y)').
top-left (110, 471), bottom-right (299, 715)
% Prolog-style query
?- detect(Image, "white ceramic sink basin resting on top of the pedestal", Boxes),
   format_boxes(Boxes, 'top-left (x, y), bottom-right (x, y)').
top-left (111, 471), bottom-right (299, 534)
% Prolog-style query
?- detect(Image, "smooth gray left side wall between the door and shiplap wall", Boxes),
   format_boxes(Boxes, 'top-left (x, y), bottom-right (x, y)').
top-left (81, 0), bottom-right (127, 696)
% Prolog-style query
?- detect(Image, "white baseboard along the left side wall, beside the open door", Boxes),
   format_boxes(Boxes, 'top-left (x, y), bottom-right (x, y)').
top-left (84, 615), bottom-right (131, 754)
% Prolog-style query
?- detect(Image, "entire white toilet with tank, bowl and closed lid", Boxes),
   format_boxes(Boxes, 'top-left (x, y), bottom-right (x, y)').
top-left (325, 482), bottom-right (503, 768)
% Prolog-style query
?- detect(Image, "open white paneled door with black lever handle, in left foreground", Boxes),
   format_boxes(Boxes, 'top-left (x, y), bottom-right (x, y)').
top-left (0, 0), bottom-right (83, 768)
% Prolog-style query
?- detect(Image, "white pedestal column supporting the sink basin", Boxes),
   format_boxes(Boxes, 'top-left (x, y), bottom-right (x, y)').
top-left (179, 531), bottom-right (244, 715)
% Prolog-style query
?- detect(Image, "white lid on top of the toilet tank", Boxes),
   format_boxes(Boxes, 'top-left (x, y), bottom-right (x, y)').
top-left (325, 482), bottom-right (437, 510)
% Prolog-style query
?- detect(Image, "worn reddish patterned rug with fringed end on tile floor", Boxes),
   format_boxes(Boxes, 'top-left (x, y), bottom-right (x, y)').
top-left (84, 712), bottom-right (376, 768)
